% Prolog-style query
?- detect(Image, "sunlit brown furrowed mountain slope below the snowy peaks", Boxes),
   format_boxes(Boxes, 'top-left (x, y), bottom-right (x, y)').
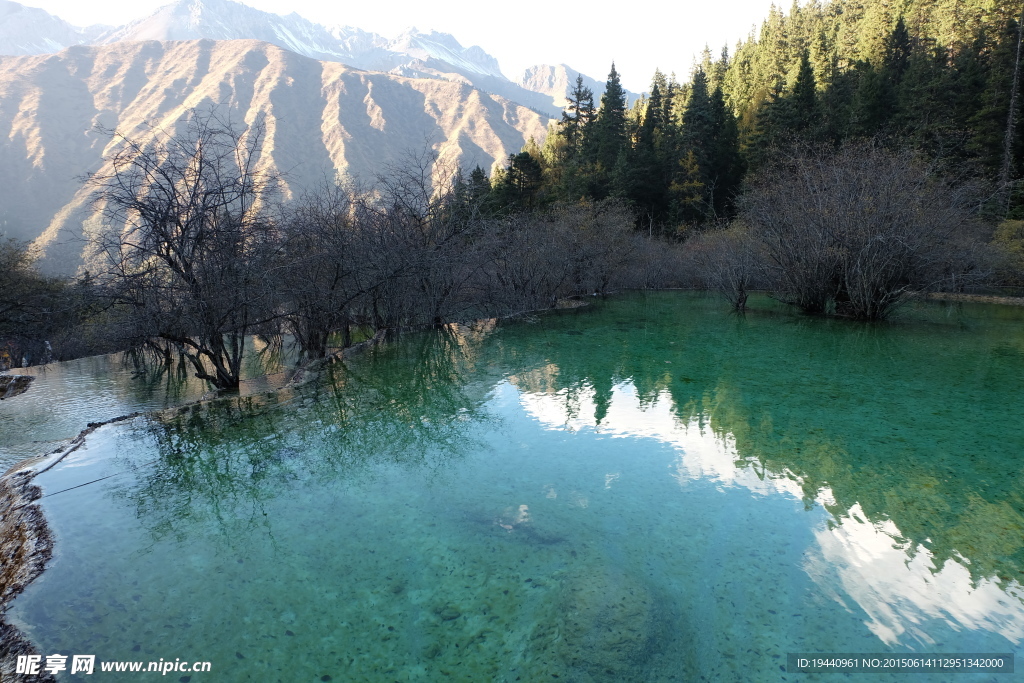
top-left (0, 40), bottom-right (549, 272)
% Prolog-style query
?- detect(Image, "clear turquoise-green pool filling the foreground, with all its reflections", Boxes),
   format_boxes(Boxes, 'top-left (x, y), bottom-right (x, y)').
top-left (10, 293), bottom-right (1024, 682)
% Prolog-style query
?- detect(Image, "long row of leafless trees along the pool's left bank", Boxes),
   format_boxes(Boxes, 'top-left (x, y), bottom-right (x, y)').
top-left (90, 124), bottom-right (688, 376)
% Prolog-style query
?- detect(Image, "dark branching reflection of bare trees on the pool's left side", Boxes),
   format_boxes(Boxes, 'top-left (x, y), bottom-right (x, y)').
top-left (116, 325), bottom-right (493, 546)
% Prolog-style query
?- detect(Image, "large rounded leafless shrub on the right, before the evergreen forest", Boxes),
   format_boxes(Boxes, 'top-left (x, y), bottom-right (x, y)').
top-left (740, 142), bottom-right (980, 319)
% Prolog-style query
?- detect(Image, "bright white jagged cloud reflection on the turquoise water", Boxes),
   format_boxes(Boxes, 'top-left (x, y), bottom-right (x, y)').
top-left (513, 379), bottom-right (1024, 650)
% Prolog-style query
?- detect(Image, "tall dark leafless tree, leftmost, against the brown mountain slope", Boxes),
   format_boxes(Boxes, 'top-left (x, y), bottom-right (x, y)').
top-left (88, 112), bottom-right (276, 389)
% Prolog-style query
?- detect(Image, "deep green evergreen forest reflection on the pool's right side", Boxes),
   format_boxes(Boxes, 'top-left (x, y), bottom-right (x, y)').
top-left (489, 294), bottom-right (1024, 593)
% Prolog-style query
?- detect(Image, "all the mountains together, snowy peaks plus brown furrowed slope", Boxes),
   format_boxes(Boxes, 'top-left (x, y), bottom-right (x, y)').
top-left (0, 0), bottom-right (638, 272)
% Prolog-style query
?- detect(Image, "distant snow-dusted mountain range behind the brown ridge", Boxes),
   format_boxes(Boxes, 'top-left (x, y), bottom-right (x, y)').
top-left (0, 0), bottom-right (637, 117)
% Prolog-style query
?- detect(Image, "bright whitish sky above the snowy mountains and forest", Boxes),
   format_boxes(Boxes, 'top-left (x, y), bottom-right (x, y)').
top-left (20, 0), bottom-right (772, 91)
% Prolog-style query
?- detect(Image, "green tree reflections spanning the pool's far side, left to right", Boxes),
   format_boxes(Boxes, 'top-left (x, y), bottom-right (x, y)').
top-left (119, 295), bottom-right (1024, 583)
